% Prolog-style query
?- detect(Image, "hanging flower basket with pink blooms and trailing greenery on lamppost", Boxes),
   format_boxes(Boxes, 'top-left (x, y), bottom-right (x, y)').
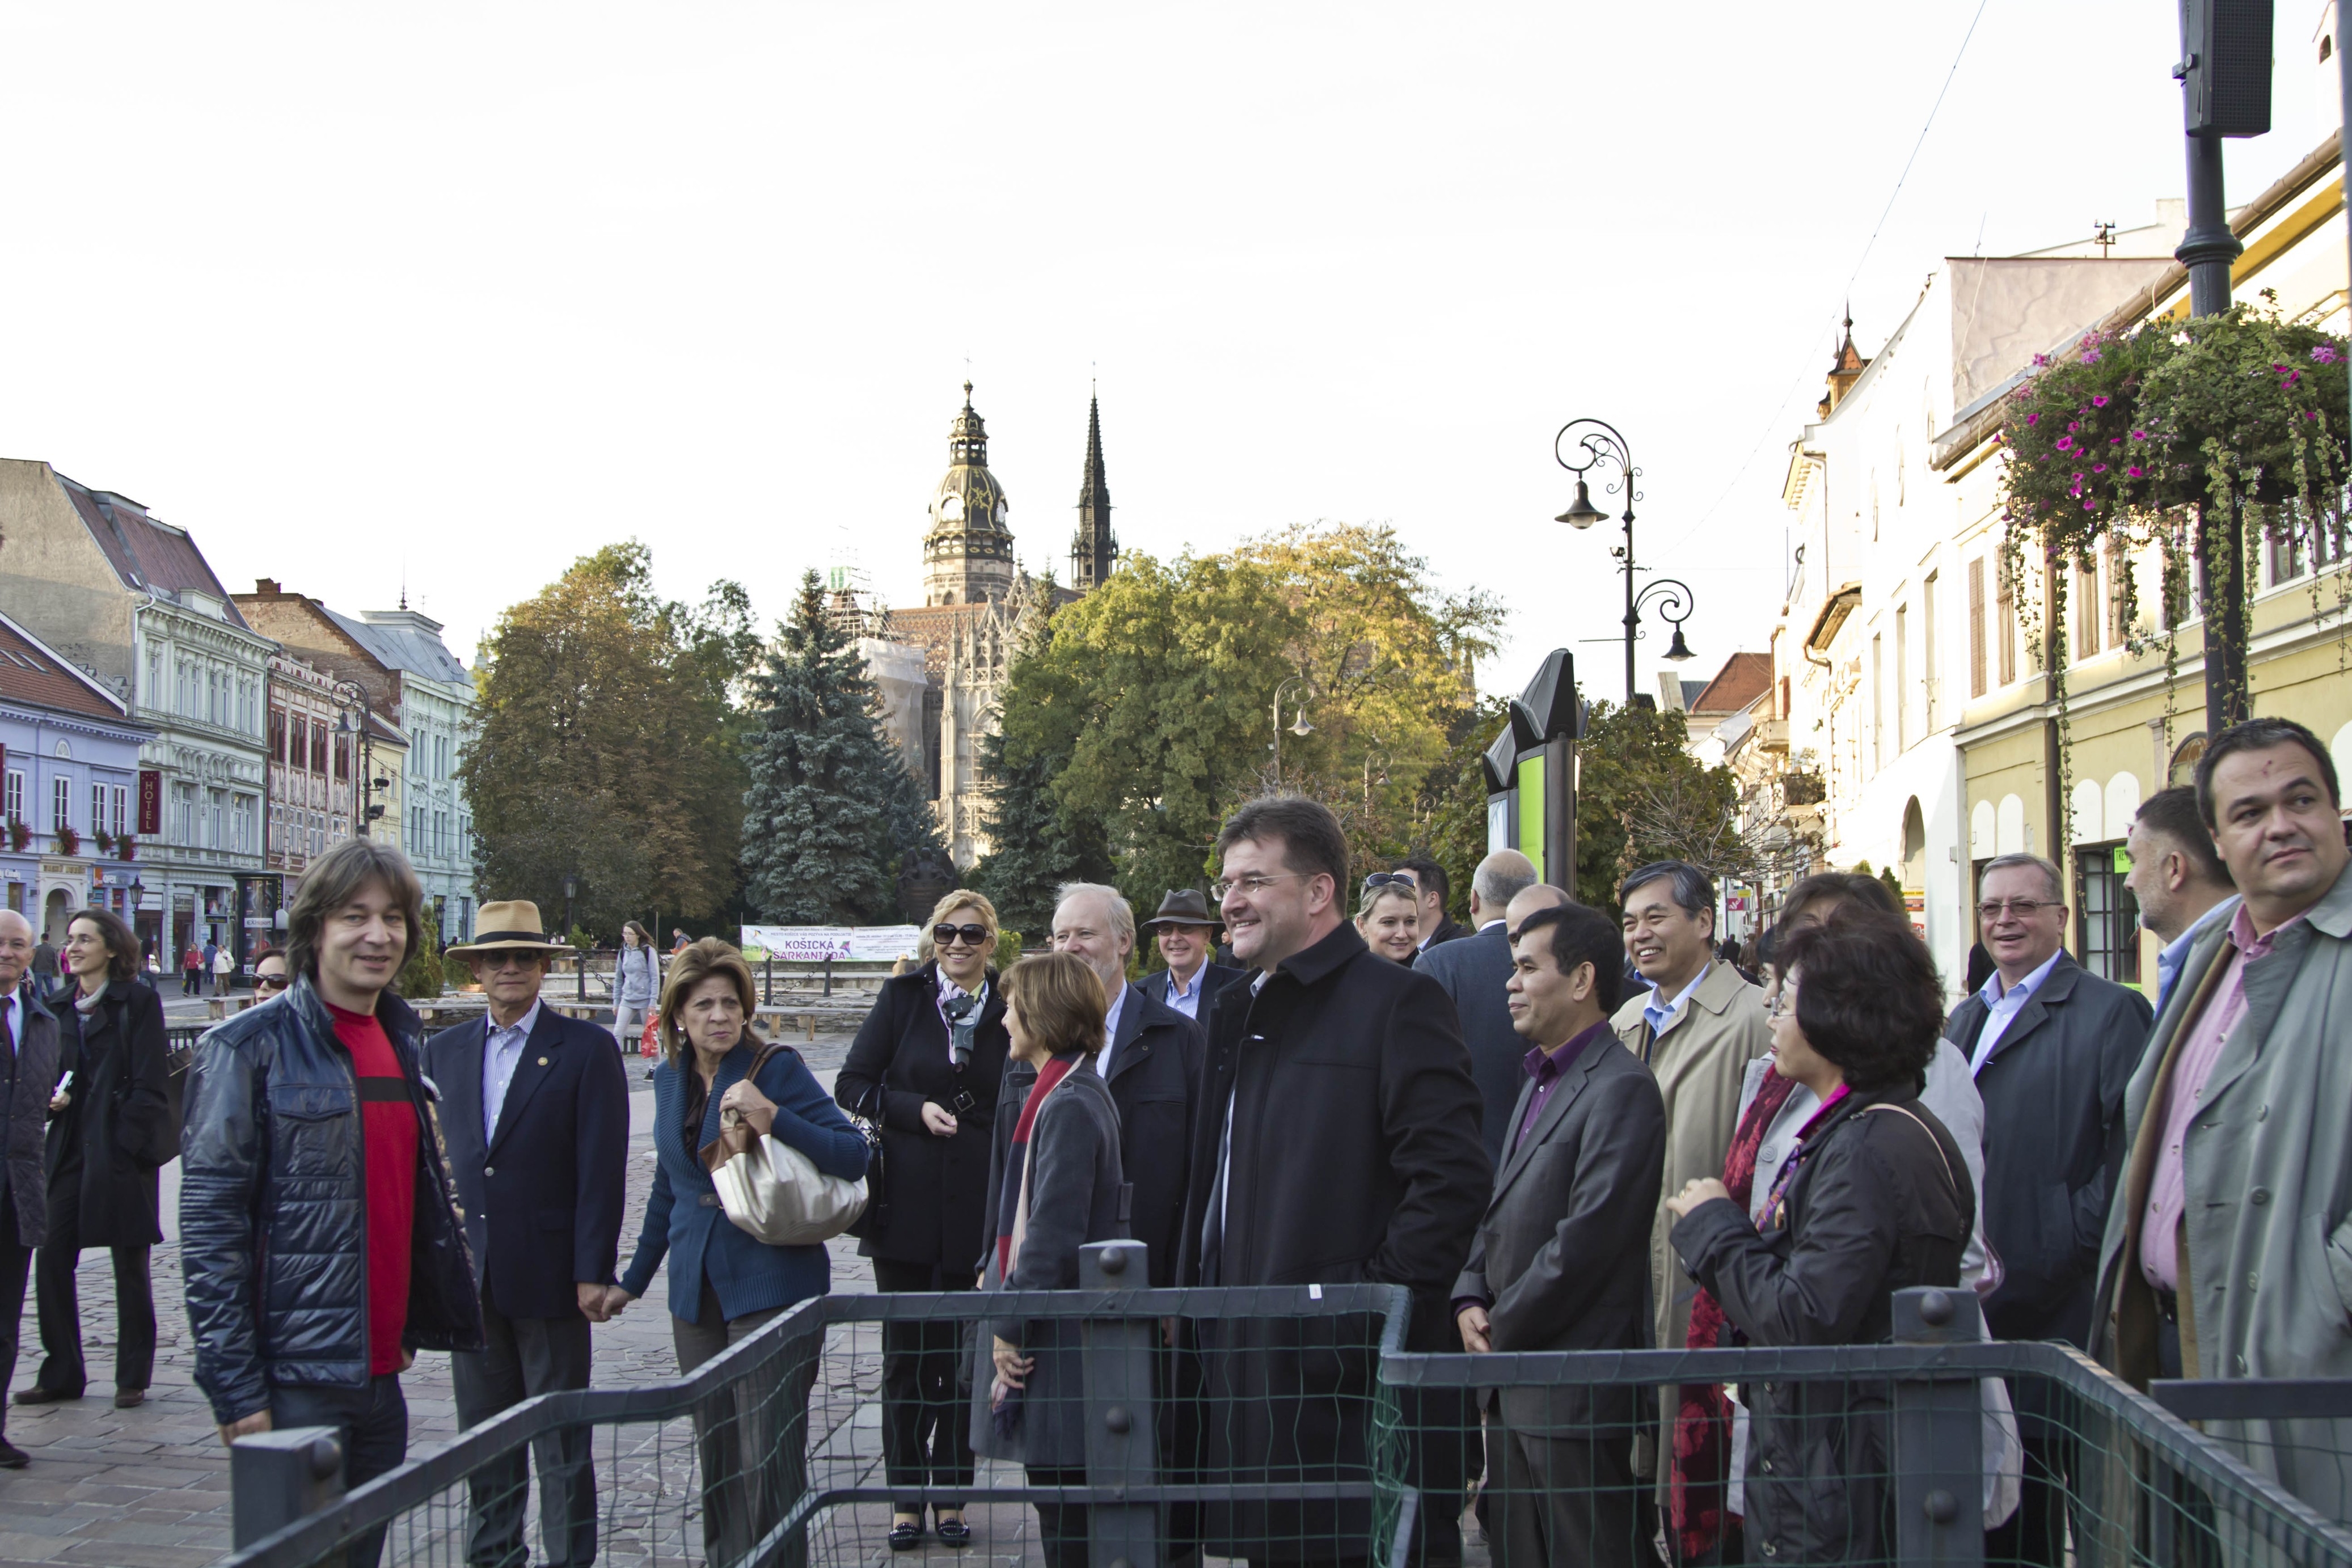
top-left (1995, 291), bottom-right (2352, 846)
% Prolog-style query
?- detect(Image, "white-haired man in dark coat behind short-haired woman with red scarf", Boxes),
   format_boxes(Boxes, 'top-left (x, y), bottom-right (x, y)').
top-left (1044, 882), bottom-right (1204, 1288)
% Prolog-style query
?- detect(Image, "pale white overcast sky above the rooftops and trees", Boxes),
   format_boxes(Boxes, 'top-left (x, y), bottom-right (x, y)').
top-left (0, 0), bottom-right (2321, 696)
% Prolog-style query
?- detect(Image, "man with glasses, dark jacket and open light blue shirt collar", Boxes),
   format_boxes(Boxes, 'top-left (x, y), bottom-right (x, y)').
top-left (1943, 853), bottom-right (2150, 1568)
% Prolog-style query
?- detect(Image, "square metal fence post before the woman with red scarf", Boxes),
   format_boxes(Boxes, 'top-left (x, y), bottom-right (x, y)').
top-left (1077, 1241), bottom-right (1159, 1568)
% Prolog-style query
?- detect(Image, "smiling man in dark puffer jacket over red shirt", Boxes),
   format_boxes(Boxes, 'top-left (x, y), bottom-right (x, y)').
top-left (179, 839), bottom-right (482, 1568)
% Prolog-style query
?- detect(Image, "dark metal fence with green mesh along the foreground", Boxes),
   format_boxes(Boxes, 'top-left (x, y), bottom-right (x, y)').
top-left (228, 1244), bottom-right (2352, 1568)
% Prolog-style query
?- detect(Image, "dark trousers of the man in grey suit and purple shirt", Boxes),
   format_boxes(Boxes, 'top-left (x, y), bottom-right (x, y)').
top-left (1487, 1427), bottom-right (1656, 1568)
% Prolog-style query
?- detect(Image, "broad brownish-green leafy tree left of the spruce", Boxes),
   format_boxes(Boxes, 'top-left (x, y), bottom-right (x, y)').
top-left (459, 540), bottom-right (755, 936)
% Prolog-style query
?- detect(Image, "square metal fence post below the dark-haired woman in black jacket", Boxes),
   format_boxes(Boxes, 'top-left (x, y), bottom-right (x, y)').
top-left (1893, 1286), bottom-right (1985, 1568)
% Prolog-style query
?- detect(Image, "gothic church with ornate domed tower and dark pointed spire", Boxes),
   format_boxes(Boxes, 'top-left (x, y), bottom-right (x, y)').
top-left (860, 381), bottom-right (1120, 870)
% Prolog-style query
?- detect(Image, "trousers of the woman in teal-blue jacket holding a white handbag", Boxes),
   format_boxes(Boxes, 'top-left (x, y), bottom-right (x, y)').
top-left (670, 1279), bottom-right (816, 1566)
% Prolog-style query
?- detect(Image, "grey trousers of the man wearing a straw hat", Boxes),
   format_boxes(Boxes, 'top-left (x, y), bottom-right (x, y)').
top-left (449, 1291), bottom-right (595, 1568)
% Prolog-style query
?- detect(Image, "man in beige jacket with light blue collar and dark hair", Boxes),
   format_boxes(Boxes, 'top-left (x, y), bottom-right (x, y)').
top-left (1609, 860), bottom-right (1771, 1532)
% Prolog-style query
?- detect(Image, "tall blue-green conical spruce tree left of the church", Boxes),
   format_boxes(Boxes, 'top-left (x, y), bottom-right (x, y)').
top-left (743, 571), bottom-right (906, 926)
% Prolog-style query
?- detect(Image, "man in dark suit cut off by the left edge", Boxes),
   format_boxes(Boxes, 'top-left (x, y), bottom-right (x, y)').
top-left (0, 910), bottom-right (70, 1469)
